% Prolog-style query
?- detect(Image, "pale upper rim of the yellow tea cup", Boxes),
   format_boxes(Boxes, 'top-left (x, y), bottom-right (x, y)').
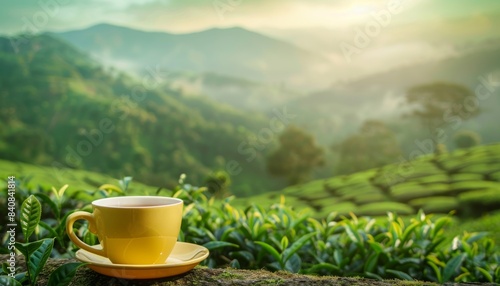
top-left (92, 196), bottom-right (184, 209)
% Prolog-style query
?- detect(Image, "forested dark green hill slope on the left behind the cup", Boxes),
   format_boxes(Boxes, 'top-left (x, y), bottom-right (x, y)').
top-left (0, 35), bottom-right (282, 194)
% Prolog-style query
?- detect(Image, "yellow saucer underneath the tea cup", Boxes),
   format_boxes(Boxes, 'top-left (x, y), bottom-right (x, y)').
top-left (76, 242), bottom-right (209, 279)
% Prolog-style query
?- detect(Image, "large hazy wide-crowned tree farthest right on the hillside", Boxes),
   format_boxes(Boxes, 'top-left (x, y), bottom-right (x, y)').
top-left (406, 82), bottom-right (480, 150)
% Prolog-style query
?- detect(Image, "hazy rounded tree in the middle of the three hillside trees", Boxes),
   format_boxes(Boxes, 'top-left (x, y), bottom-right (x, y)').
top-left (332, 120), bottom-right (401, 174)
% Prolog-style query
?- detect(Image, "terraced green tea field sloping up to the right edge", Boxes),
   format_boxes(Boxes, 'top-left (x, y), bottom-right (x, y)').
top-left (235, 144), bottom-right (500, 217)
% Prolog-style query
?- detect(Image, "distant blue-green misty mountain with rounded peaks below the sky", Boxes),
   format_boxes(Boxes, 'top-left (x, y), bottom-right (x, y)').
top-left (52, 24), bottom-right (332, 88)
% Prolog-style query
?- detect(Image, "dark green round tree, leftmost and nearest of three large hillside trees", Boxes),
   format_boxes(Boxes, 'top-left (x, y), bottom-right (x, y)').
top-left (267, 126), bottom-right (325, 185)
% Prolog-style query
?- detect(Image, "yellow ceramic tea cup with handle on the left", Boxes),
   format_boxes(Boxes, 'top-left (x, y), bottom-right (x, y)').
top-left (66, 196), bottom-right (183, 264)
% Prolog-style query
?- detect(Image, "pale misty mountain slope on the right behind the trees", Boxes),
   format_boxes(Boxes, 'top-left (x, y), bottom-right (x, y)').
top-left (289, 44), bottom-right (500, 144)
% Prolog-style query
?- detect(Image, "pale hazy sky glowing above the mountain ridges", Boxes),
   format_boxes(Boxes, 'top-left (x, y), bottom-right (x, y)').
top-left (0, 0), bottom-right (500, 34)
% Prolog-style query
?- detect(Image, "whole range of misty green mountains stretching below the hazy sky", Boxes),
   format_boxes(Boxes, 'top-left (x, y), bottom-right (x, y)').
top-left (0, 24), bottom-right (500, 194)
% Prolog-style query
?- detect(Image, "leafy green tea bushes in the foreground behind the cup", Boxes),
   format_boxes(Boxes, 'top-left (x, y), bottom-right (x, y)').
top-left (0, 177), bottom-right (500, 283)
